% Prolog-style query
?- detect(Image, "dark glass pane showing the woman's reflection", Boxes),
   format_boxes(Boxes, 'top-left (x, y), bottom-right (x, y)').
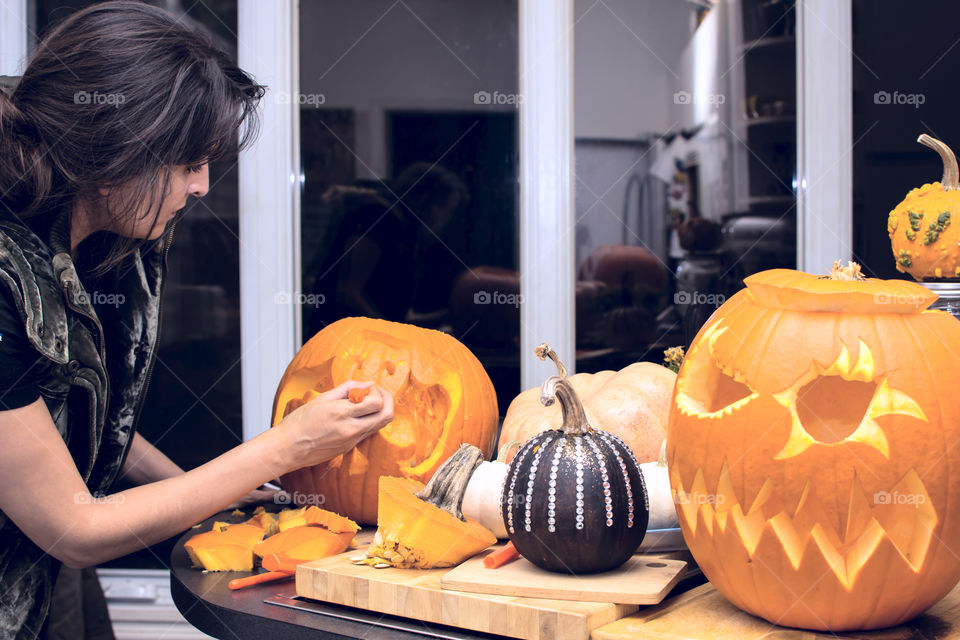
top-left (298, 0), bottom-right (520, 411)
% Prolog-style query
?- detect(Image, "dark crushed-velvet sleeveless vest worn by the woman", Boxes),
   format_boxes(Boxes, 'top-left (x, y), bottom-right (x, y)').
top-left (0, 212), bottom-right (173, 638)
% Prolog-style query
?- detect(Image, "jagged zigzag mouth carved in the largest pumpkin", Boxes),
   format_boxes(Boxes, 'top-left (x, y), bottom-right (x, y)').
top-left (670, 461), bottom-right (939, 591)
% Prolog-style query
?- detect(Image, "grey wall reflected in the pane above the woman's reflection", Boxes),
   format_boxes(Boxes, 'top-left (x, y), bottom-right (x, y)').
top-left (300, 0), bottom-right (518, 178)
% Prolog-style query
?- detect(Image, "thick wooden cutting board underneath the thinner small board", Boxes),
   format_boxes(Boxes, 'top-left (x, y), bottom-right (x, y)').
top-left (296, 532), bottom-right (688, 640)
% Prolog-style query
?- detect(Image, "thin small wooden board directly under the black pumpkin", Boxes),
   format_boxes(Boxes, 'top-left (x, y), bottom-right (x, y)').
top-left (440, 554), bottom-right (687, 604)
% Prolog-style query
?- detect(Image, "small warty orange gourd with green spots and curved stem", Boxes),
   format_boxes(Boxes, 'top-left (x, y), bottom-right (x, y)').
top-left (887, 134), bottom-right (960, 280)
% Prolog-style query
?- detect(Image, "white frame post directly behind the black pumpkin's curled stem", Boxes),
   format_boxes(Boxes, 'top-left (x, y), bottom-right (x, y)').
top-left (520, 0), bottom-right (576, 390)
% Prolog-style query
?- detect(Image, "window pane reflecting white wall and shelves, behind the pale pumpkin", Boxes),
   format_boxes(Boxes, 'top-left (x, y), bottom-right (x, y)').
top-left (574, 0), bottom-right (796, 364)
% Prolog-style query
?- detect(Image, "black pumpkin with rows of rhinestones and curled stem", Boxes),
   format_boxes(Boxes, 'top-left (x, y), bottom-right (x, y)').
top-left (500, 376), bottom-right (649, 574)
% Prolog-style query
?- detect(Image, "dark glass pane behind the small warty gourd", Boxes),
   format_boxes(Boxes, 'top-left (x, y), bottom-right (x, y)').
top-left (853, 0), bottom-right (960, 280)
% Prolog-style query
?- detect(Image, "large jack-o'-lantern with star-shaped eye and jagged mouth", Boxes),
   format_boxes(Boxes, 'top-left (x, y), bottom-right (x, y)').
top-left (667, 265), bottom-right (960, 631)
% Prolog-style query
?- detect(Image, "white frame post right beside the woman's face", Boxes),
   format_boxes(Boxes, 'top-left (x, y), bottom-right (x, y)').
top-left (237, 0), bottom-right (300, 440)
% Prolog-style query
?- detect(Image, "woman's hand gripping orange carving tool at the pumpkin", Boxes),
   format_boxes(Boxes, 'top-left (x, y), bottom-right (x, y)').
top-left (271, 380), bottom-right (393, 471)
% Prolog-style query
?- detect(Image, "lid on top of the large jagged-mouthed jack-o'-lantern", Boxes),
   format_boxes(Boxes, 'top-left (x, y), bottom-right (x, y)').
top-left (744, 266), bottom-right (937, 313)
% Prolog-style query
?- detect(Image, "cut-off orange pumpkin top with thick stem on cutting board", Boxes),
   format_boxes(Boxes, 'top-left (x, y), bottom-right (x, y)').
top-left (357, 445), bottom-right (497, 569)
